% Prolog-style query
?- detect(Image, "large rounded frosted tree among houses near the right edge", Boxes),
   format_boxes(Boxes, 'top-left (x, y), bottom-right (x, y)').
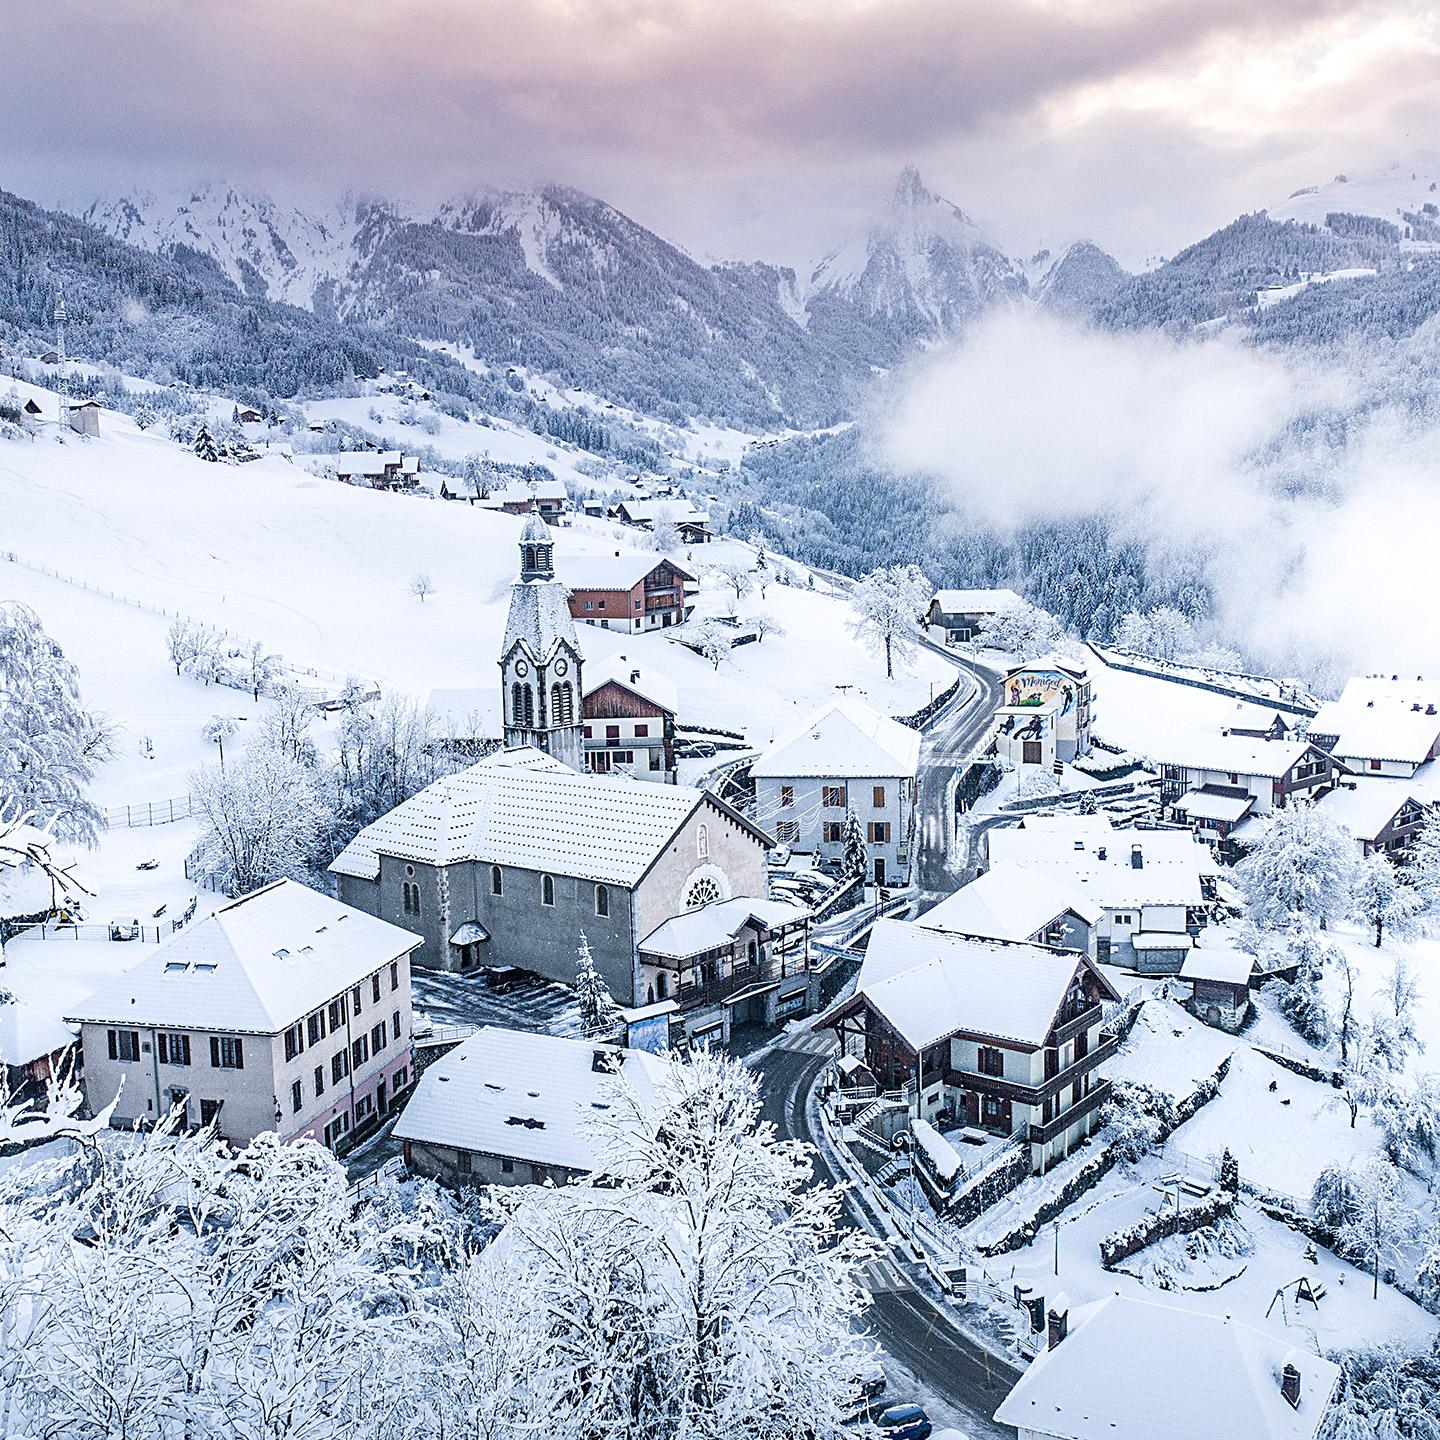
top-left (1236, 802), bottom-right (1355, 930)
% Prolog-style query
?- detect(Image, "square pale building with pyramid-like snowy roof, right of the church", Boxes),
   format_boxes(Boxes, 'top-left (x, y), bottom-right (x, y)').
top-left (750, 697), bottom-right (920, 886)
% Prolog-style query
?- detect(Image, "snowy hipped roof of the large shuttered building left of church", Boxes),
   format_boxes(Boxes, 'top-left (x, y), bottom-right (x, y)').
top-left (66, 880), bottom-right (420, 1034)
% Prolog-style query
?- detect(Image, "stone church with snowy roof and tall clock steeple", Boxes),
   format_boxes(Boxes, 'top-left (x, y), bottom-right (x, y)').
top-left (330, 516), bottom-right (773, 1036)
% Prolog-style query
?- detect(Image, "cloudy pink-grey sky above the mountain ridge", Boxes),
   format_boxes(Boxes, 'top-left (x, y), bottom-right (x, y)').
top-left (11, 0), bottom-right (1440, 265)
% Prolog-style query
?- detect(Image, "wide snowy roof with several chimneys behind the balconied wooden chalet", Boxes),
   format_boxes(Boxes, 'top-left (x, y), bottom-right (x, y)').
top-left (988, 815), bottom-right (1220, 910)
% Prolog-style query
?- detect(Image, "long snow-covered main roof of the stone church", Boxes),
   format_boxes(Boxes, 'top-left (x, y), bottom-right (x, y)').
top-left (330, 749), bottom-right (763, 887)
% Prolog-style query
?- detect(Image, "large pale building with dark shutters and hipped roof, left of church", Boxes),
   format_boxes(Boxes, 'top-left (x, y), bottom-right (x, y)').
top-left (66, 880), bottom-right (420, 1148)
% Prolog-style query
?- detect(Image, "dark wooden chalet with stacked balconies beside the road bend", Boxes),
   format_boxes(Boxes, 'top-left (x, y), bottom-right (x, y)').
top-left (816, 920), bottom-right (1119, 1172)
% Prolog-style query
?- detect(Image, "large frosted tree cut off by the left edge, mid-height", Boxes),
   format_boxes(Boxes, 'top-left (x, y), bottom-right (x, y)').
top-left (0, 602), bottom-right (112, 844)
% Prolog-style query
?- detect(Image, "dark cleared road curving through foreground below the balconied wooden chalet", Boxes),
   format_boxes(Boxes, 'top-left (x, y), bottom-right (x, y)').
top-left (755, 1037), bottom-right (1020, 1440)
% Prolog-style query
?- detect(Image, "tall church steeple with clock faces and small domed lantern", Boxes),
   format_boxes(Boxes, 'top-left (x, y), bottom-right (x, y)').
top-left (500, 514), bottom-right (585, 770)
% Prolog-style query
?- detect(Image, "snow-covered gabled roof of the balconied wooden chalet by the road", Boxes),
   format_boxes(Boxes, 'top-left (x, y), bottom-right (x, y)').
top-left (841, 920), bottom-right (1116, 1051)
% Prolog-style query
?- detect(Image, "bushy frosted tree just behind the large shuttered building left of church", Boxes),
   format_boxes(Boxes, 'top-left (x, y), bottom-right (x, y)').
top-left (190, 737), bottom-right (327, 894)
